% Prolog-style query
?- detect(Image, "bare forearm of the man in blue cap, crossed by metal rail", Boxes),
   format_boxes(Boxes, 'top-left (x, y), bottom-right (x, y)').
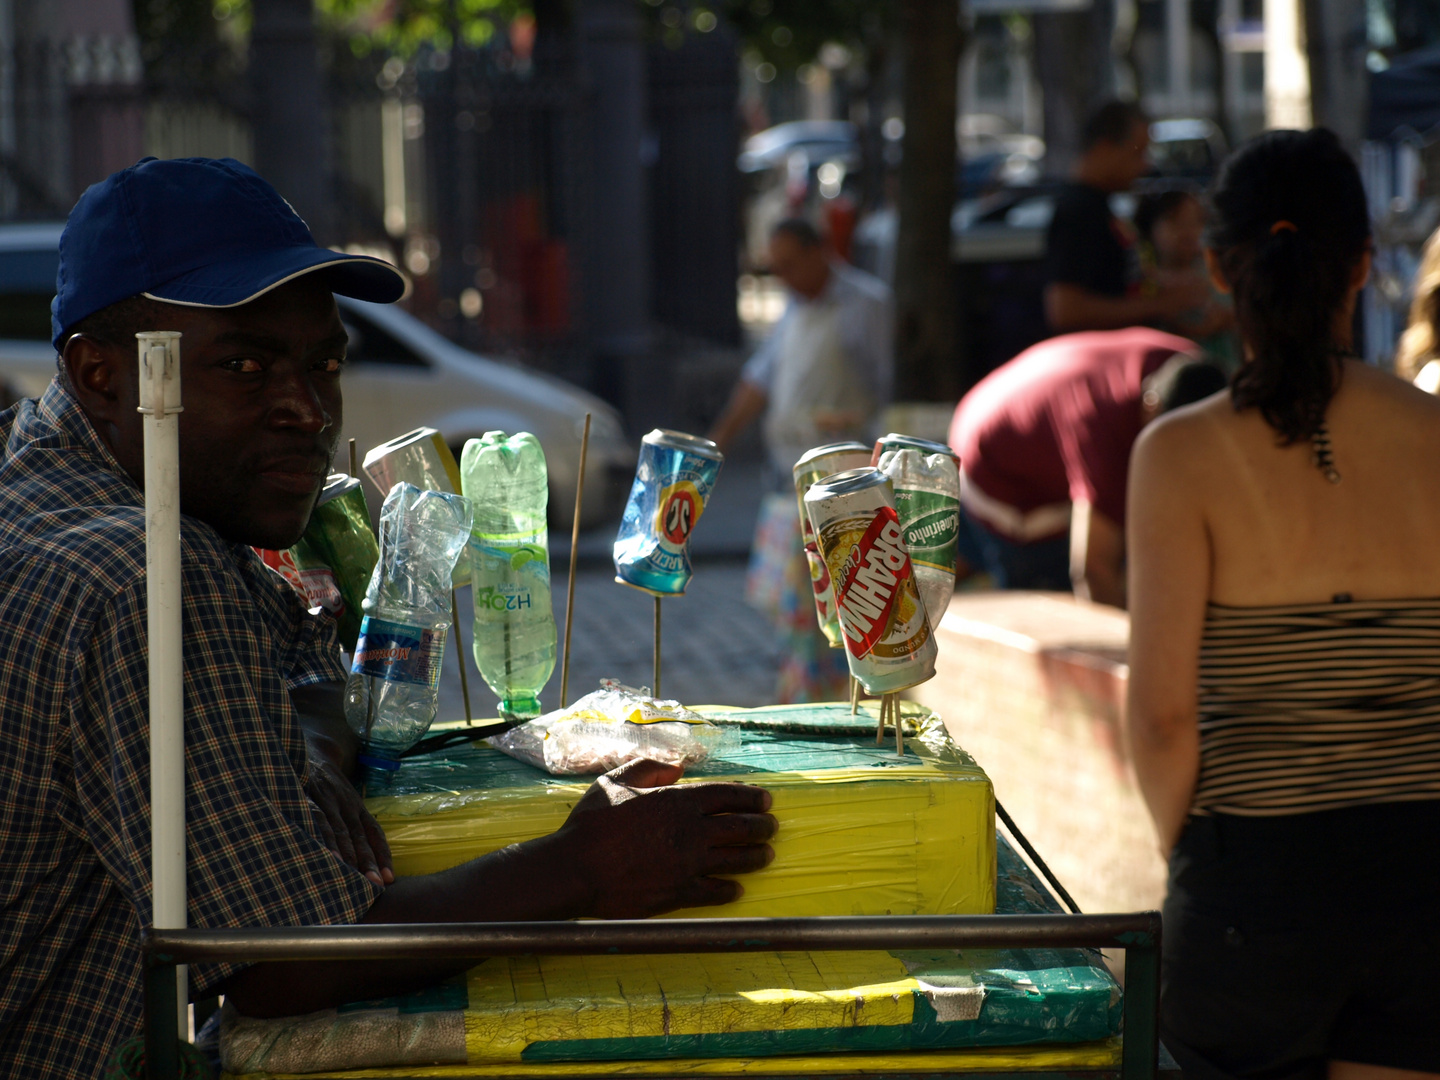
top-left (225, 834), bottom-right (589, 1017)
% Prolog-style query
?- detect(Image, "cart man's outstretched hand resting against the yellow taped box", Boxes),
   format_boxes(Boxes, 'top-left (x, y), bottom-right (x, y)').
top-left (554, 760), bottom-right (776, 919)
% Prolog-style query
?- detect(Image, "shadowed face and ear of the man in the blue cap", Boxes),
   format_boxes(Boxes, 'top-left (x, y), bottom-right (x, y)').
top-left (72, 274), bottom-right (346, 549)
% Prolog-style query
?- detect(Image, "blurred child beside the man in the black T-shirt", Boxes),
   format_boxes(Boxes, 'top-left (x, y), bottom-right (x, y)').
top-left (1135, 192), bottom-right (1240, 376)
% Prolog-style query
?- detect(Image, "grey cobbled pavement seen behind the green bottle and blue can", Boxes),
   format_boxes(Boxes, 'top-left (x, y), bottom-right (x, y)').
top-left (439, 557), bottom-right (776, 719)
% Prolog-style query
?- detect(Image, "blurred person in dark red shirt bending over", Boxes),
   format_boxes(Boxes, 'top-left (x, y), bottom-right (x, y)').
top-left (950, 327), bottom-right (1225, 608)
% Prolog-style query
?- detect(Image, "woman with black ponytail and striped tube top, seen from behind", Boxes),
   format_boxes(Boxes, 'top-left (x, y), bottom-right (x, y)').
top-left (1126, 130), bottom-right (1440, 1080)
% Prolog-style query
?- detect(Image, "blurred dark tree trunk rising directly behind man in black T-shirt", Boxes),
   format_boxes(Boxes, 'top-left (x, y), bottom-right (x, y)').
top-left (1034, 0), bottom-right (1115, 177)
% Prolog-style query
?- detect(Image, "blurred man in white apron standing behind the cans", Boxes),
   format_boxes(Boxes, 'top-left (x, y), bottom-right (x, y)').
top-left (710, 217), bottom-right (893, 701)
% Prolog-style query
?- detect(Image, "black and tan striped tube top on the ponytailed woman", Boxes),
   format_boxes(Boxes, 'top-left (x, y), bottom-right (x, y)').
top-left (1191, 599), bottom-right (1440, 816)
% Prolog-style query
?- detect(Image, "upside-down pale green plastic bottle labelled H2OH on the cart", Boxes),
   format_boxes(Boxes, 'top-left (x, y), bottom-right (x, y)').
top-left (459, 431), bottom-right (554, 720)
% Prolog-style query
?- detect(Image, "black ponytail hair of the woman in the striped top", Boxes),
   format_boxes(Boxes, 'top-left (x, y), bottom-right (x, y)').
top-left (1205, 128), bottom-right (1369, 444)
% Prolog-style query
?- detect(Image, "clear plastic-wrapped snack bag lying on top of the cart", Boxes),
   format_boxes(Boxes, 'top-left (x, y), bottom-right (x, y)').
top-left (488, 678), bottom-right (737, 776)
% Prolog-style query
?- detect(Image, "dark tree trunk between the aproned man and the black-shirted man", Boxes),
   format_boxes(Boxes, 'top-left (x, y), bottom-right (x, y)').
top-left (894, 0), bottom-right (962, 402)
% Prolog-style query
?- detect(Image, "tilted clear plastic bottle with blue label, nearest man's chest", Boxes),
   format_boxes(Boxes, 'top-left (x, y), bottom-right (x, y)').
top-left (346, 484), bottom-right (471, 786)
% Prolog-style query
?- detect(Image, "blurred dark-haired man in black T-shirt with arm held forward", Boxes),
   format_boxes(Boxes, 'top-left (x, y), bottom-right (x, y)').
top-left (1045, 101), bottom-right (1208, 334)
